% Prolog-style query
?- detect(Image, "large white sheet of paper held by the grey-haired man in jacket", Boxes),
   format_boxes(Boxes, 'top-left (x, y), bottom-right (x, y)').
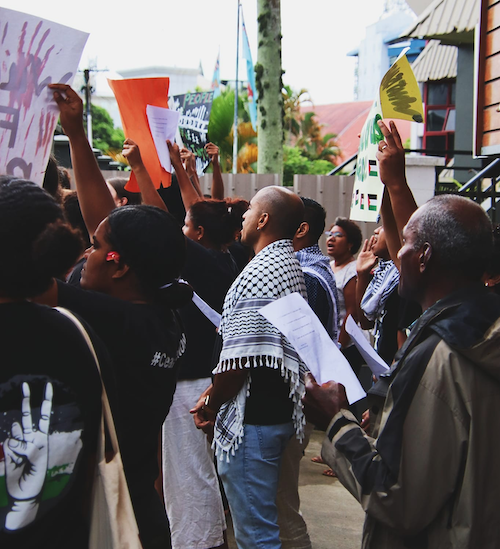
top-left (259, 293), bottom-right (366, 404)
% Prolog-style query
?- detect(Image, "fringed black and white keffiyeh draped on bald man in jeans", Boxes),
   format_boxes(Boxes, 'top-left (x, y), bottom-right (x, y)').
top-left (213, 240), bottom-right (307, 461)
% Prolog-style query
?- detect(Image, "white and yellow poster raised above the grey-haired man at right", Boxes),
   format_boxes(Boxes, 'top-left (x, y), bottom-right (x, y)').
top-left (350, 50), bottom-right (424, 222)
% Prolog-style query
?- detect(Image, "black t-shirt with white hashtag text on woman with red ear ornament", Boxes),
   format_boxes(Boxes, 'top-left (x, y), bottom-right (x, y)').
top-left (58, 282), bottom-right (182, 490)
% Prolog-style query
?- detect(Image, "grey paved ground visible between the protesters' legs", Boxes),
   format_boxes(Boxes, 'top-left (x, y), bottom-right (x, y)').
top-left (228, 431), bottom-right (364, 549)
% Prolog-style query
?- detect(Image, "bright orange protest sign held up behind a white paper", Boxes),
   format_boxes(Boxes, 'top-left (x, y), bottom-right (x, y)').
top-left (108, 78), bottom-right (172, 192)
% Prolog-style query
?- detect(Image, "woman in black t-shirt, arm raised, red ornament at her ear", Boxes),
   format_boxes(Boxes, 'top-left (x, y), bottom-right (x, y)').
top-left (45, 84), bottom-right (192, 548)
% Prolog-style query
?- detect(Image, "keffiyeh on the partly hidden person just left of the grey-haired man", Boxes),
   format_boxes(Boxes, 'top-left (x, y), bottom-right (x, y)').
top-left (361, 259), bottom-right (399, 320)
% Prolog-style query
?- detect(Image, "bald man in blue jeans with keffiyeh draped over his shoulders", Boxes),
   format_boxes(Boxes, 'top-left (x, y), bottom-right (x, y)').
top-left (193, 187), bottom-right (306, 549)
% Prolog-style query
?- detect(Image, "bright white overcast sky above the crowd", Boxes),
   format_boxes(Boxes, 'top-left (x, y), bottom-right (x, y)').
top-left (1, 0), bottom-right (384, 105)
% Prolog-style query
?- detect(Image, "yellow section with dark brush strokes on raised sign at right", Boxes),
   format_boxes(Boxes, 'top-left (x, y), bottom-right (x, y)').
top-left (380, 52), bottom-right (424, 122)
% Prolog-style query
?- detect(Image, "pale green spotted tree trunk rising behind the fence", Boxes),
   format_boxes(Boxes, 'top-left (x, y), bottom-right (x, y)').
top-left (255, 0), bottom-right (283, 176)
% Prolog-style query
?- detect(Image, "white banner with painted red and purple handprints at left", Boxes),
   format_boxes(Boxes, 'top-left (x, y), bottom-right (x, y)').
top-left (0, 8), bottom-right (88, 185)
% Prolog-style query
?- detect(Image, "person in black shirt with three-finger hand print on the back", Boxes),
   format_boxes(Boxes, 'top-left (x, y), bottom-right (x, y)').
top-left (0, 176), bottom-right (103, 549)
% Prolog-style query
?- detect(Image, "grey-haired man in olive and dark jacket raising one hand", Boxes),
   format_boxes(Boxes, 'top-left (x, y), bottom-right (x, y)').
top-left (305, 122), bottom-right (500, 549)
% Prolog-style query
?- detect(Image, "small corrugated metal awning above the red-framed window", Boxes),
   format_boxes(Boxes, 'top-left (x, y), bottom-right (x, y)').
top-left (411, 40), bottom-right (458, 82)
